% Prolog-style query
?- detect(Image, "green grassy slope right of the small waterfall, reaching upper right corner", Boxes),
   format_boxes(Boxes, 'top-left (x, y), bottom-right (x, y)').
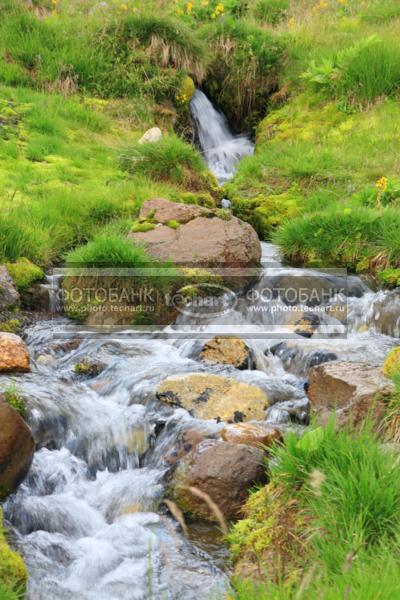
top-left (228, 0), bottom-right (400, 278)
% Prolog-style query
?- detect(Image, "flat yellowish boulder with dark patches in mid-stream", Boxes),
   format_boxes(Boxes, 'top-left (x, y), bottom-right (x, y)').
top-left (157, 373), bottom-right (269, 423)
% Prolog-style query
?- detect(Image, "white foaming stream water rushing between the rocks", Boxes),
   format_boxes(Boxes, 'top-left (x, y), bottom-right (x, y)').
top-left (1, 93), bottom-right (400, 600)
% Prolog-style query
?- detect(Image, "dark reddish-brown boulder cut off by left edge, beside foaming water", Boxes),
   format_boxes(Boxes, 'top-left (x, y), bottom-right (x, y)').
top-left (0, 394), bottom-right (35, 496)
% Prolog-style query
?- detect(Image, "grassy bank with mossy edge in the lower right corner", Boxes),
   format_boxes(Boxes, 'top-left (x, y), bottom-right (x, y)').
top-left (229, 412), bottom-right (400, 600)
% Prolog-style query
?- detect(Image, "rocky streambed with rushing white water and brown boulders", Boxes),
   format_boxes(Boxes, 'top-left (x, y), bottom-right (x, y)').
top-left (0, 245), bottom-right (399, 600)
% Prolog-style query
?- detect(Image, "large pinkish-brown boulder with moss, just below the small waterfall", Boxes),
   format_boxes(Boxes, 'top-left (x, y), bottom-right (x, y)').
top-left (129, 198), bottom-right (261, 268)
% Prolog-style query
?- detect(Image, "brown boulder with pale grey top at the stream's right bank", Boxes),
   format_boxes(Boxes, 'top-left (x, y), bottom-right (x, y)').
top-left (308, 361), bottom-right (394, 425)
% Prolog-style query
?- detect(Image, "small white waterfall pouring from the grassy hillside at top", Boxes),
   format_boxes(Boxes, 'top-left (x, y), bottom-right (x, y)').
top-left (190, 90), bottom-right (254, 183)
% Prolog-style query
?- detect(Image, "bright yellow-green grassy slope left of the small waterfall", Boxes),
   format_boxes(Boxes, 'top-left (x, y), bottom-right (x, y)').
top-left (0, 86), bottom-right (186, 266)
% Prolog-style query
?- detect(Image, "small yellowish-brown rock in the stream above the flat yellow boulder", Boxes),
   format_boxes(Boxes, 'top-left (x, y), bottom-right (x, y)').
top-left (200, 337), bottom-right (255, 369)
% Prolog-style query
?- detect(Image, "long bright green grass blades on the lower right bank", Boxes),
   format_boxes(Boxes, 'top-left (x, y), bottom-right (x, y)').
top-left (231, 422), bottom-right (400, 600)
